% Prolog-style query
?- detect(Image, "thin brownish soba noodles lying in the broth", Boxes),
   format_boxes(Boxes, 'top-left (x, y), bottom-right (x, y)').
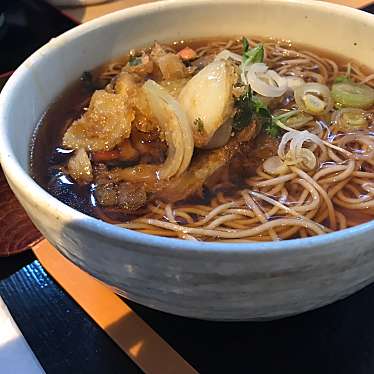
top-left (120, 39), bottom-right (374, 241)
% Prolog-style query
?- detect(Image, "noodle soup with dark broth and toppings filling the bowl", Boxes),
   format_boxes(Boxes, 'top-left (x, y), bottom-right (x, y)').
top-left (31, 37), bottom-right (374, 242)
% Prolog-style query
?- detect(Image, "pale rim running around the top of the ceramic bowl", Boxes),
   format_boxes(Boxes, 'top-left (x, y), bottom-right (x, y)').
top-left (0, 0), bottom-right (374, 255)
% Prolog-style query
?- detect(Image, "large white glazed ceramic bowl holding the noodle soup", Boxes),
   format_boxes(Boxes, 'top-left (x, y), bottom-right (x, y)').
top-left (0, 0), bottom-right (374, 320)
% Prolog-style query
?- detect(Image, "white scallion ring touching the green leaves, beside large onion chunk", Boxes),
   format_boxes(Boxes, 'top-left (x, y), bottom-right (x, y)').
top-left (242, 63), bottom-right (287, 97)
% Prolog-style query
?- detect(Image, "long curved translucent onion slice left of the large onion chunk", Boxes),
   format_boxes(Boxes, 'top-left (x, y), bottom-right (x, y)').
top-left (143, 79), bottom-right (194, 179)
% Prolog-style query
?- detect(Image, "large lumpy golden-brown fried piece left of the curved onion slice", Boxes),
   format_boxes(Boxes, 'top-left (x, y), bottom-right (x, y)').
top-left (63, 90), bottom-right (135, 151)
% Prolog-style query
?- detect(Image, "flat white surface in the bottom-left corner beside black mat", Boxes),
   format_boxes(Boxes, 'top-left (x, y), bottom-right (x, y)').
top-left (0, 297), bottom-right (45, 374)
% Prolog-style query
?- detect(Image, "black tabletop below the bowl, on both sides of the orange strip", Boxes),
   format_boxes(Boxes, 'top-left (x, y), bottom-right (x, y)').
top-left (0, 0), bottom-right (374, 374)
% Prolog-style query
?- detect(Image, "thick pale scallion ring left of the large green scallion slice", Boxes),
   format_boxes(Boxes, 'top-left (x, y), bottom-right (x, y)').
top-left (294, 83), bottom-right (333, 115)
